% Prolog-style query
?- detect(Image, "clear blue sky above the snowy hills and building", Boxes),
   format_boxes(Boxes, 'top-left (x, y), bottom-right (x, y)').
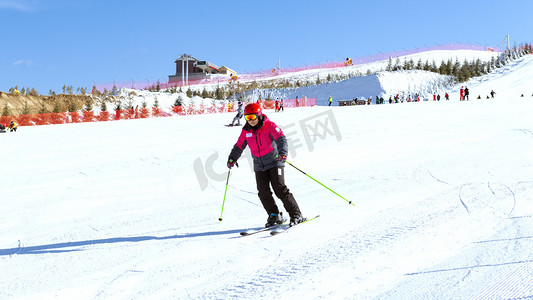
top-left (0, 0), bottom-right (533, 94)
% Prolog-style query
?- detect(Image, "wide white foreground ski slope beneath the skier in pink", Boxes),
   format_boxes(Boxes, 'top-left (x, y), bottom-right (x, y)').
top-left (0, 51), bottom-right (533, 299)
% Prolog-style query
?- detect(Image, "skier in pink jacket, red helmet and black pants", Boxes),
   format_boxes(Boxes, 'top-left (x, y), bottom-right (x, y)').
top-left (227, 103), bottom-right (306, 227)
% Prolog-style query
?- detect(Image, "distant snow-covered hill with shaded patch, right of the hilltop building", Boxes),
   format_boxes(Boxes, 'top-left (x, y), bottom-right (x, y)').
top-left (273, 50), bottom-right (501, 105)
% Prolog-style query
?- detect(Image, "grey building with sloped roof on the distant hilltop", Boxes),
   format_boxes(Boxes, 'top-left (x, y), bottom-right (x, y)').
top-left (168, 54), bottom-right (237, 83)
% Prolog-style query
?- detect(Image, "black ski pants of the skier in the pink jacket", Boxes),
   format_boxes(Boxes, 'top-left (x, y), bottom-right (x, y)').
top-left (255, 167), bottom-right (302, 216)
